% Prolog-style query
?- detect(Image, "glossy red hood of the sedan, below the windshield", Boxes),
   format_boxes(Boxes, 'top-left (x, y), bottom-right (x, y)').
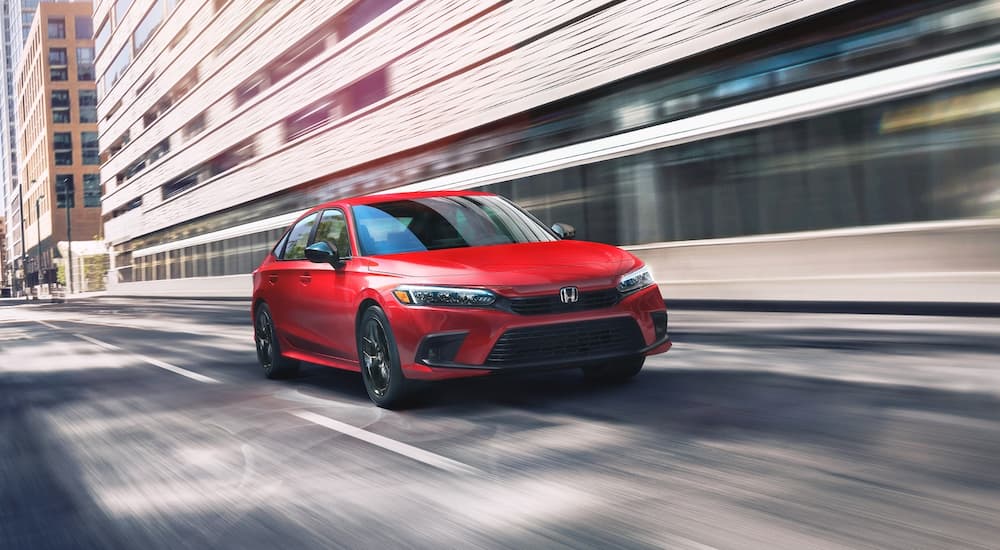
top-left (369, 241), bottom-right (642, 294)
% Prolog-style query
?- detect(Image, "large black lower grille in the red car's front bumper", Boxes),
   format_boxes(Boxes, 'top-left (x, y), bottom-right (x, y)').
top-left (486, 317), bottom-right (645, 366)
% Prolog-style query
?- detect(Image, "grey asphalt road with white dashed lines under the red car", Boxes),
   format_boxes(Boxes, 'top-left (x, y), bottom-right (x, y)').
top-left (0, 299), bottom-right (1000, 550)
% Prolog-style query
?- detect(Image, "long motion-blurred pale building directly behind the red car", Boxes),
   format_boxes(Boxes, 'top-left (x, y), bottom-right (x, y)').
top-left (94, 0), bottom-right (1000, 301)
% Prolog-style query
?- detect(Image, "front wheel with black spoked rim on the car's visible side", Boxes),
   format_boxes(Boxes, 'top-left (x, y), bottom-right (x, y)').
top-left (357, 306), bottom-right (412, 409)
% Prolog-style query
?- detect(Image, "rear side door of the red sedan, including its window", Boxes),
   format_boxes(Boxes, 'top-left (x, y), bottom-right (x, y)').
top-left (263, 212), bottom-right (319, 350)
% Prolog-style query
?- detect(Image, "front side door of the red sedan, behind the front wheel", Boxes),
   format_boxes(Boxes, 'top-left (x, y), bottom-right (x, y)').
top-left (302, 208), bottom-right (357, 359)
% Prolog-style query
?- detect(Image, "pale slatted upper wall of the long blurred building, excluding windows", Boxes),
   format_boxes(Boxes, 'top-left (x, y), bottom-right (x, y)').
top-left (95, 0), bottom-right (841, 248)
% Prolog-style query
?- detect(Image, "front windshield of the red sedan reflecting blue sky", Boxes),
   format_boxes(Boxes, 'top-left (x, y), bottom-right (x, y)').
top-left (353, 195), bottom-right (556, 256)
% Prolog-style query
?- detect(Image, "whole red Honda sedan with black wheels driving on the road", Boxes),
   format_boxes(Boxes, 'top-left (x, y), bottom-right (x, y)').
top-left (253, 192), bottom-right (671, 407)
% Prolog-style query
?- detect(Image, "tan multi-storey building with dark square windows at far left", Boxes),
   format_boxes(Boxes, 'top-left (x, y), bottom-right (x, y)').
top-left (14, 2), bottom-right (102, 292)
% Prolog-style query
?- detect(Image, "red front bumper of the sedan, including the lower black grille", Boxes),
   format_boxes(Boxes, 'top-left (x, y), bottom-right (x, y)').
top-left (387, 286), bottom-right (671, 380)
